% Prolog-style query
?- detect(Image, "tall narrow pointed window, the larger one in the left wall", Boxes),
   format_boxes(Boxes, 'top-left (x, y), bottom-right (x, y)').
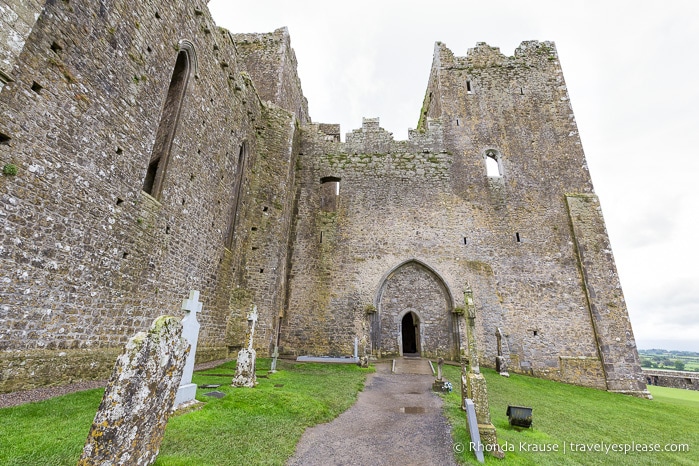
top-left (143, 50), bottom-right (190, 199)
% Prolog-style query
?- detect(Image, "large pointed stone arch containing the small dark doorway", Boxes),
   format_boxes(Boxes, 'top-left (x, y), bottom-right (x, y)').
top-left (371, 260), bottom-right (459, 359)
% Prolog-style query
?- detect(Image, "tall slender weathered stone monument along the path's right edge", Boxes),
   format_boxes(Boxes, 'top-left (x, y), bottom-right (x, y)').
top-left (461, 285), bottom-right (505, 458)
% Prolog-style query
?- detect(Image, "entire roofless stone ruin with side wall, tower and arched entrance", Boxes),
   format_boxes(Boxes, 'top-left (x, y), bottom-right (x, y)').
top-left (0, 0), bottom-right (645, 394)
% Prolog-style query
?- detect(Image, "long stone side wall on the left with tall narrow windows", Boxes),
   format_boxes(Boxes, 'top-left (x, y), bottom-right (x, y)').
top-left (0, 0), bottom-right (297, 391)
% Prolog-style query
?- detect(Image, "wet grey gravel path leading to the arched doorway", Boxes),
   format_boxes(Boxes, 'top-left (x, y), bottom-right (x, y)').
top-left (288, 359), bottom-right (456, 466)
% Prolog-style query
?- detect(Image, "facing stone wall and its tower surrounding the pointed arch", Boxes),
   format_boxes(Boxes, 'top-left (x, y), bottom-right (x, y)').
top-left (282, 42), bottom-right (643, 392)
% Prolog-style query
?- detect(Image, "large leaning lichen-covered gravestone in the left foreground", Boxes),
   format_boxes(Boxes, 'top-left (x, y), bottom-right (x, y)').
top-left (78, 316), bottom-right (189, 466)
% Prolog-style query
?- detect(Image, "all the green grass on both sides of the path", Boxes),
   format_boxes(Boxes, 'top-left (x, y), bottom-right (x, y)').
top-left (0, 359), bottom-right (699, 466)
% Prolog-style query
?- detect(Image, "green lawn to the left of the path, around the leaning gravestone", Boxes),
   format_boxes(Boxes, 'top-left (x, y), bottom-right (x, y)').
top-left (0, 359), bottom-right (370, 466)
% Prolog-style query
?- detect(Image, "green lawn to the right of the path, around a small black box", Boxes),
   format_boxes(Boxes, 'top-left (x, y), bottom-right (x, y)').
top-left (445, 366), bottom-right (699, 465)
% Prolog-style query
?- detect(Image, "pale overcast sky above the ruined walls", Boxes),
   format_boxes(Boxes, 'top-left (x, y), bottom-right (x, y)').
top-left (209, 0), bottom-right (699, 351)
